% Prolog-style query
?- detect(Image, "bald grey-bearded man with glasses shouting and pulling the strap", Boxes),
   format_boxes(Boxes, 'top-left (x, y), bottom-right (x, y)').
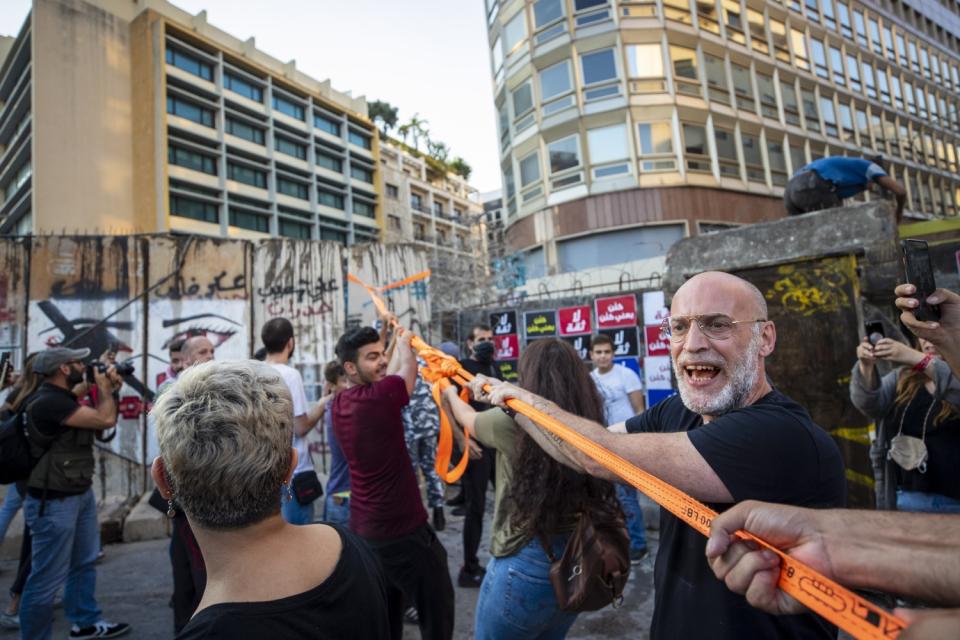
top-left (470, 272), bottom-right (846, 640)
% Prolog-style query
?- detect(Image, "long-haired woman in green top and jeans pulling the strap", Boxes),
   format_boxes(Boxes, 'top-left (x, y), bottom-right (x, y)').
top-left (444, 339), bottom-right (619, 640)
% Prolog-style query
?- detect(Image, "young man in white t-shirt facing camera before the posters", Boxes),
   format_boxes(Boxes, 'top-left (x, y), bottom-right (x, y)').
top-left (590, 334), bottom-right (647, 564)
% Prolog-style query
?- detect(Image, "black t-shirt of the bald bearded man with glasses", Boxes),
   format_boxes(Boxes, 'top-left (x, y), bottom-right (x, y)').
top-left (626, 390), bottom-right (846, 640)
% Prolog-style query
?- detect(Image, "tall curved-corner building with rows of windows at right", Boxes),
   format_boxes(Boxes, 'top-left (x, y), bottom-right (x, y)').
top-left (486, 0), bottom-right (960, 292)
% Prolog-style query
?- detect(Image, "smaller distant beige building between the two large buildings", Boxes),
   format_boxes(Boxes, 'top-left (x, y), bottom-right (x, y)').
top-left (380, 141), bottom-right (487, 310)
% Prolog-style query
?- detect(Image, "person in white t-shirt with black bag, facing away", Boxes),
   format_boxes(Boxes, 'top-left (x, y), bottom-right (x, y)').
top-left (260, 318), bottom-right (332, 524)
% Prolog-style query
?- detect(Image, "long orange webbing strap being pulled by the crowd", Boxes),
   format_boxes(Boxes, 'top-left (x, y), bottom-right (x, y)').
top-left (347, 275), bottom-right (906, 640)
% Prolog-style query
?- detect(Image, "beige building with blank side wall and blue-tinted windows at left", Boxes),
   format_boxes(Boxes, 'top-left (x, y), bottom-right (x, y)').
top-left (0, 0), bottom-right (381, 243)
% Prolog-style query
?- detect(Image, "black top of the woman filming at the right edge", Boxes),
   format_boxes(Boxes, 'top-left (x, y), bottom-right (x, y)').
top-left (887, 388), bottom-right (960, 500)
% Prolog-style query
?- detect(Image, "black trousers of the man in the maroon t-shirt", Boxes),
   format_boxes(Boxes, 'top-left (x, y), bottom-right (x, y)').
top-left (367, 523), bottom-right (454, 640)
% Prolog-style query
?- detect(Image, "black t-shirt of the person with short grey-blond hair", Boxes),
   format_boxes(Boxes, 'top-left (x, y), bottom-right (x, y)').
top-left (177, 525), bottom-right (390, 640)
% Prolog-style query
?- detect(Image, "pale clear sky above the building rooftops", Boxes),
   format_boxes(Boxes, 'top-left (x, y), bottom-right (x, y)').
top-left (0, 0), bottom-right (500, 192)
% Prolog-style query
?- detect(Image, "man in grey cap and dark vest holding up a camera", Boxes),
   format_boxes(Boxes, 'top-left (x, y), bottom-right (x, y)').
top-left (20, 347), bottom-right (130, 640)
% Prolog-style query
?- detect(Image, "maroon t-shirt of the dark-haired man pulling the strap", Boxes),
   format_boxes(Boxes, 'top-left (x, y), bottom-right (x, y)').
top-left (333, 376), bottom-right (427, 540)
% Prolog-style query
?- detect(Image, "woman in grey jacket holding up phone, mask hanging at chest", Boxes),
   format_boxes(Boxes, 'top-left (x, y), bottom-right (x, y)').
top-left (850, 333), bottom-right (960, 513)
